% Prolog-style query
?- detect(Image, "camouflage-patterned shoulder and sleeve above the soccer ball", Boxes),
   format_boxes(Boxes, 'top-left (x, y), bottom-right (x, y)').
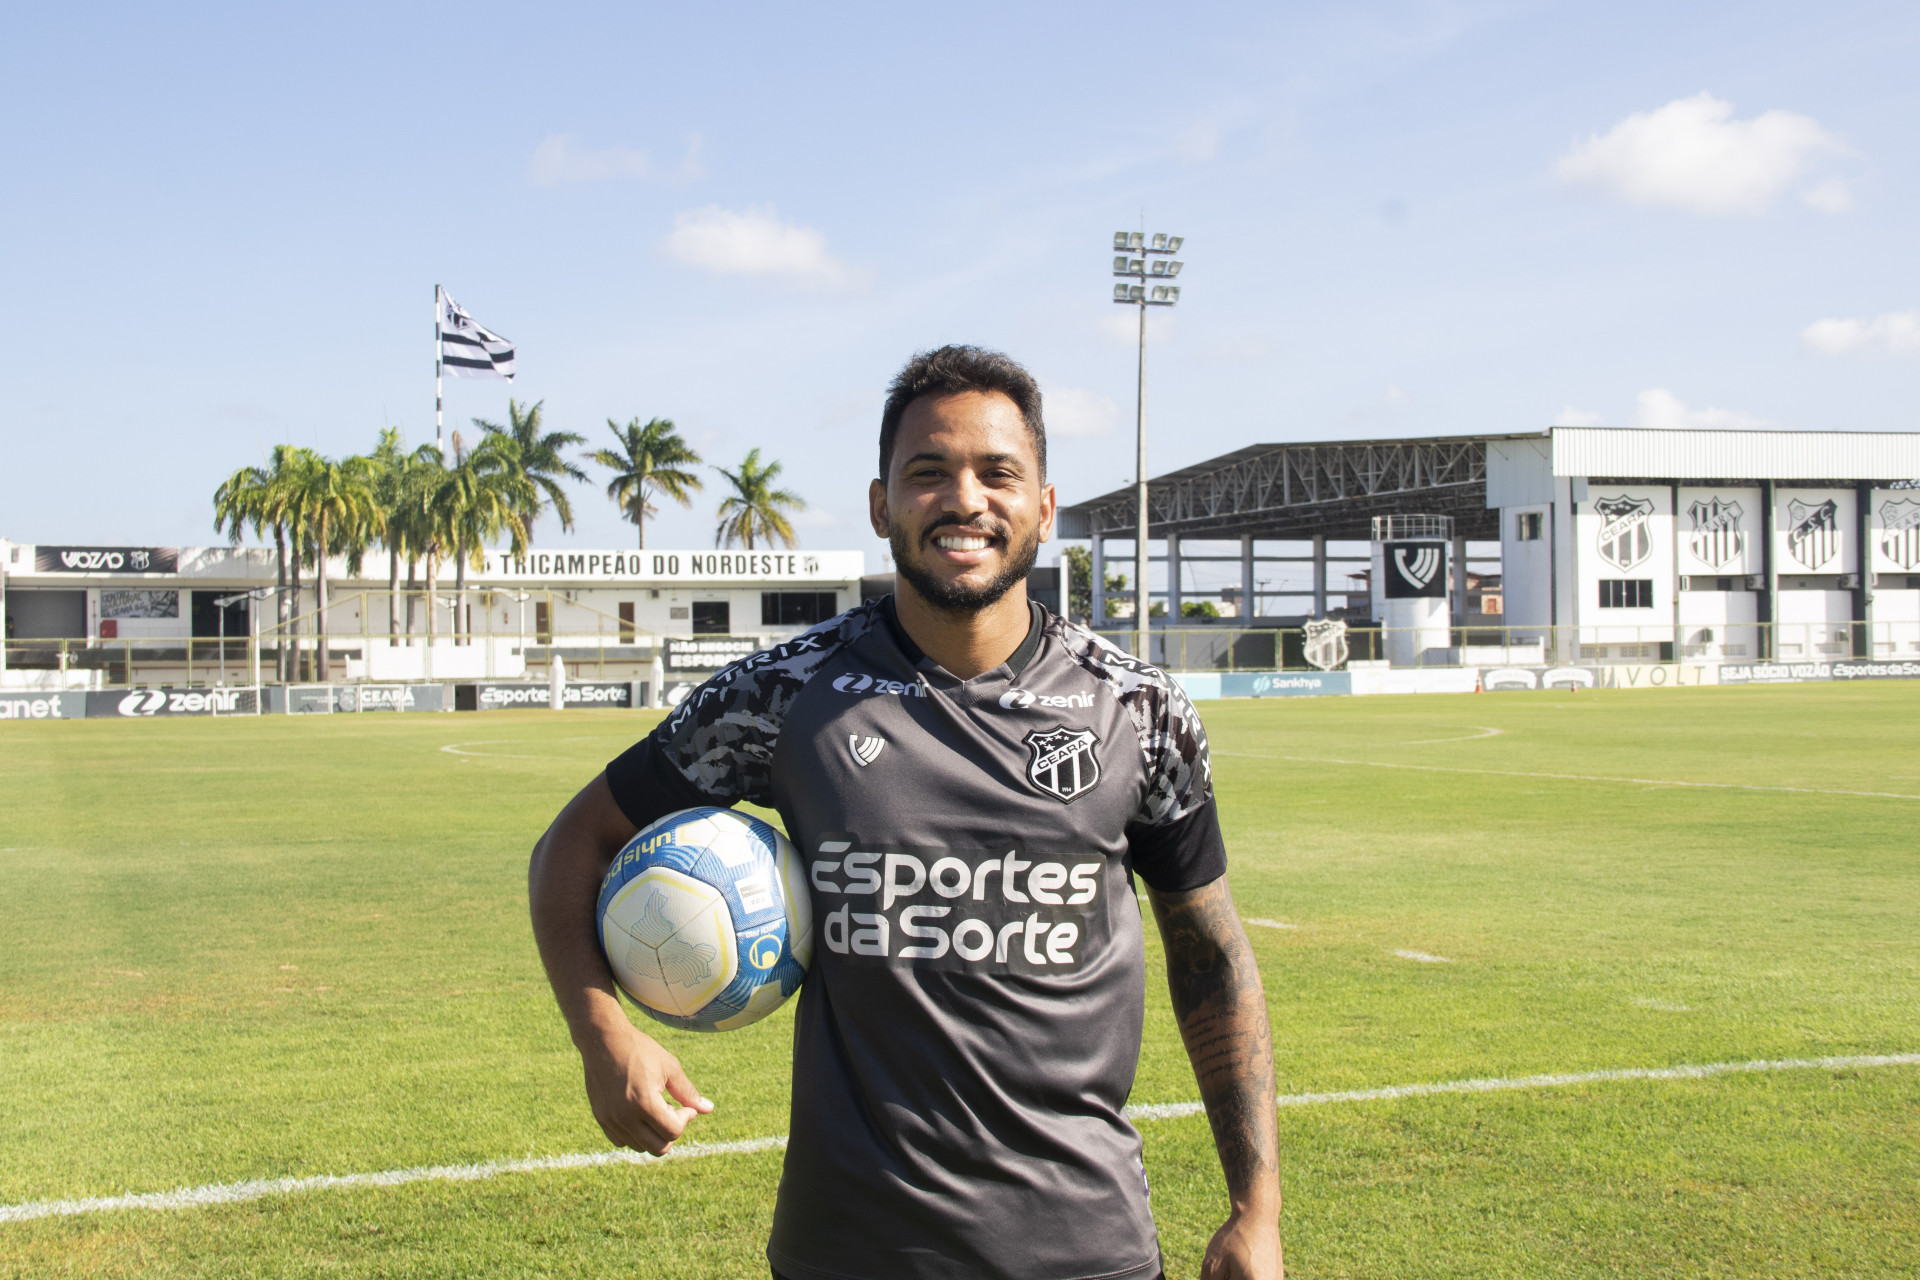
top-left (609, 606), bottom-right (872, 808)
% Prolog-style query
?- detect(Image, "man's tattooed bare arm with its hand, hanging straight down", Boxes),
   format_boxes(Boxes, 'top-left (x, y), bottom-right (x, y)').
top-left (1148, 877), bottom-right (1281, 1280)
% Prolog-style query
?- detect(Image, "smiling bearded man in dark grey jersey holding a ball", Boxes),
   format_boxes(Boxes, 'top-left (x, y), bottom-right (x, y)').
top-left (530, 347), bottom-right (1281, 1280)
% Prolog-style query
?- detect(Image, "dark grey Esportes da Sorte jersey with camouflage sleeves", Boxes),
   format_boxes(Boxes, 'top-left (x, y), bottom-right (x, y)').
top-left (607, 601), bottom-right (1225, 1280)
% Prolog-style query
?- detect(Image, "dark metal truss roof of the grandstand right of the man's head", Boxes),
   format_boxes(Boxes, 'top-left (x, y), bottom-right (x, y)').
top-left (1060, 432), bottom-right (1548, 541)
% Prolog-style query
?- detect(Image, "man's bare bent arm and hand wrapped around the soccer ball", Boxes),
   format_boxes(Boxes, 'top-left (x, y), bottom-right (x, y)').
top-left (526, 773), bottom-right (714, 1155)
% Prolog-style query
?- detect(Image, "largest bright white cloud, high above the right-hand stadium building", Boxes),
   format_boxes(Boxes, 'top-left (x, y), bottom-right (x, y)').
top-left (1553, 92), bottom-right (1853, 215)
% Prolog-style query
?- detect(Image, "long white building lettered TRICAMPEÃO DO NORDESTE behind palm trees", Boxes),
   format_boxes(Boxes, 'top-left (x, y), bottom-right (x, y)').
top-left (0, 543), bottom-right (864, 702)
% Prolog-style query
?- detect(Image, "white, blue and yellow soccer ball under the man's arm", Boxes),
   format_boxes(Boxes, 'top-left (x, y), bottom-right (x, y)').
top-left (597, 808), bottom-right (814, 1031)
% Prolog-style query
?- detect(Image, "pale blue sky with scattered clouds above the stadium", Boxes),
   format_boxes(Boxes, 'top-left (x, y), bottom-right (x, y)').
top-left (0, 4), bottom-right (1920, 564)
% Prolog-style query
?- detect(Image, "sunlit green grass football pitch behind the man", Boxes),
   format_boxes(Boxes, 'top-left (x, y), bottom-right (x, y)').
top-left (0, 685), bottom-right (1920, 1278)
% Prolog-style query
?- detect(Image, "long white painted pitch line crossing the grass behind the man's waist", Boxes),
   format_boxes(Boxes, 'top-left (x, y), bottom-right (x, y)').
top-left (0, 1054), bottom-right (1920, 1222)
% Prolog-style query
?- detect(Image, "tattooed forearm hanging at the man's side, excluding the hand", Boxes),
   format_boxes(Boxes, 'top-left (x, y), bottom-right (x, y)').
top-left (1150, 877), bottom-right (1279, 1205)
